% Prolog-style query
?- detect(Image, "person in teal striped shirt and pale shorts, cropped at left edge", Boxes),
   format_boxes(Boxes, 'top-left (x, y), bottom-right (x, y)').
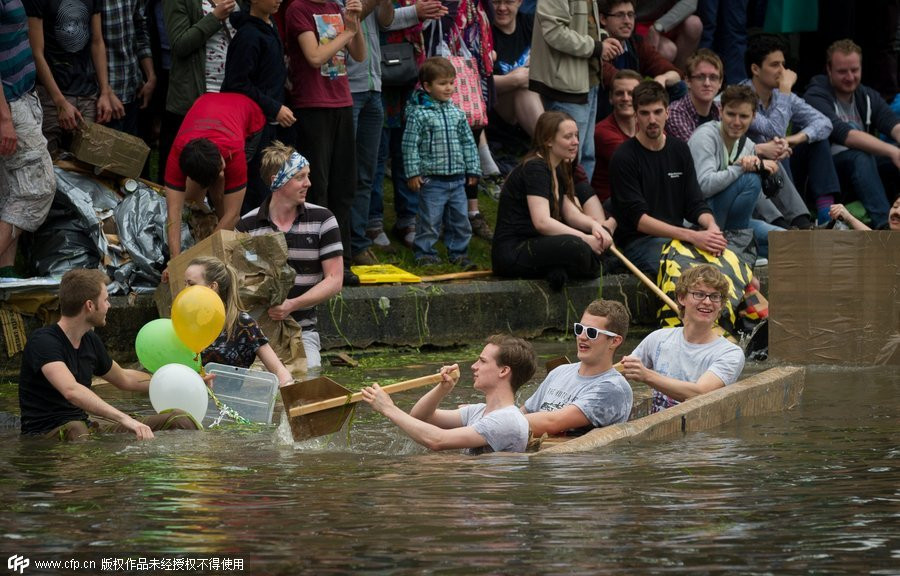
top-left (0, 0), bottom-right (56, 277)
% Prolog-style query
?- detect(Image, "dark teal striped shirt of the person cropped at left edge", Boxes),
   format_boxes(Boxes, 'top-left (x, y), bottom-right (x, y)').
top-left (0, 0), bottom-right (35, 102)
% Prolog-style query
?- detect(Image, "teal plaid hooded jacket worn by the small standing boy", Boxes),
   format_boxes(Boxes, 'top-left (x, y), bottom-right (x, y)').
top-left (402, 90), bottom-right (481, 178)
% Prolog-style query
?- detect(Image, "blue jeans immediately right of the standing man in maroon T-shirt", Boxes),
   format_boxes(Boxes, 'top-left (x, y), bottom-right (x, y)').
top-left (350, 90), bottom-right (384, 254)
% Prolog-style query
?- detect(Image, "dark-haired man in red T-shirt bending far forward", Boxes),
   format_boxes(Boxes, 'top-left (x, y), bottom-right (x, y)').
top-left (166, 93), bottom-right (266, 258)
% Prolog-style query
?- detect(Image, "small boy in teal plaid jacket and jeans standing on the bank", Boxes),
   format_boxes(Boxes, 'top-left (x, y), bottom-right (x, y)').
top-left (403, 56), bottom-right (481, 270)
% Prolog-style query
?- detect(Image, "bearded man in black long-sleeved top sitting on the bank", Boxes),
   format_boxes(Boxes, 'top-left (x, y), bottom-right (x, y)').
top-left (610, 80), bottom-right (727, 277)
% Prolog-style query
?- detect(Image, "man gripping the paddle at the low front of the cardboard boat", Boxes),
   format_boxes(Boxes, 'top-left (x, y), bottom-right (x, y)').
top-left (362, 334), bottom-right (537, 454)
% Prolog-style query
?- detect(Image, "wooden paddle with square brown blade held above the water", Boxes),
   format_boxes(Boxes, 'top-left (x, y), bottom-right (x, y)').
top-left (281, 370), bottom-right (459, 441)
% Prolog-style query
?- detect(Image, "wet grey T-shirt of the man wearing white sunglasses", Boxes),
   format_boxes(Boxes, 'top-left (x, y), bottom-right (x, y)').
top-left (525, 362), bottom-right (634, 428)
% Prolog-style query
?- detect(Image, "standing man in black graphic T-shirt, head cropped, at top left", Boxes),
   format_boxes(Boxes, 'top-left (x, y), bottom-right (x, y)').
top-left (24, 0), bottom-right (118, 158)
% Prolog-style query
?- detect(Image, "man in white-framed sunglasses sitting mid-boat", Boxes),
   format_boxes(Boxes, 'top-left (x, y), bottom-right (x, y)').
top-left (522, 300), bottom-right (634, 436)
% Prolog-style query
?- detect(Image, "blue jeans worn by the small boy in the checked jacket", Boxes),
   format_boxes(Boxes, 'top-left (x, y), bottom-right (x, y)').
top-left (413, 176), bottom-right (472, 260)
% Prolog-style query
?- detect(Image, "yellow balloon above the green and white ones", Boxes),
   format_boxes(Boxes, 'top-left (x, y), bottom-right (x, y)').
top-left (172, 286), bottom-right (225, 354)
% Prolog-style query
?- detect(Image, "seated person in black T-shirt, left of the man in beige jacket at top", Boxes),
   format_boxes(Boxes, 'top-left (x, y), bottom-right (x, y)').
top-left (491, 0), bottom-right (544, 138)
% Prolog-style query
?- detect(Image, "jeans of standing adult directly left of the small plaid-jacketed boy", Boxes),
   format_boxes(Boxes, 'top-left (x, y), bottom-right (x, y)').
top-left (368, 127), bottom-right (419, 228)
